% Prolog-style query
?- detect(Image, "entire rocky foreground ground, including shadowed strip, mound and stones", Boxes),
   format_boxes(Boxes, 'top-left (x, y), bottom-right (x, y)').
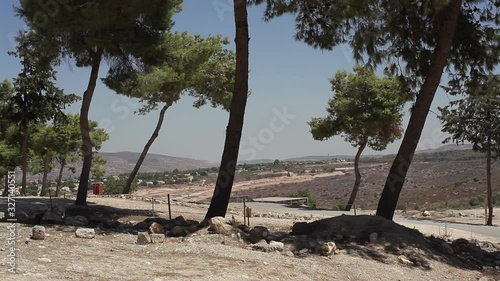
top-left (0, 198), bottom-right (500, 280)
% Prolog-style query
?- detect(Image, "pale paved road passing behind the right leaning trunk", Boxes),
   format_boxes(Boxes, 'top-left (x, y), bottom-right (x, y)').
top-left (231, 202), bottom-right (500, 239)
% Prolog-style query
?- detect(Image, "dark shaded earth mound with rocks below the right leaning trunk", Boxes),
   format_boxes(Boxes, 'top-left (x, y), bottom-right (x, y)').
top-left (292, 215), bottom-right (500, 278)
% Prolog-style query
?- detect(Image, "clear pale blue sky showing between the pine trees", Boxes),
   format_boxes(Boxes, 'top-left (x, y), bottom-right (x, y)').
top-left (0, 0), bottom-right (454, 162)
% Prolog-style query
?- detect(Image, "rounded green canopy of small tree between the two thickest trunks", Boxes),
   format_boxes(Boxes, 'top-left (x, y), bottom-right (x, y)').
top-left (309, 67), bottom-right (410, 150)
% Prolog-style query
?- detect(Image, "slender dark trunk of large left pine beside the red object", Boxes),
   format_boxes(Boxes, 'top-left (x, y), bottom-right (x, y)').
top-left (75, 48), bottom-right (103, 205)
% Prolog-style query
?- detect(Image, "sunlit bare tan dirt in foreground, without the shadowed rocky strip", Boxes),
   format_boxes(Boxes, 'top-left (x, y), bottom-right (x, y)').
top-left (0, 197), bottom-right (500, 281)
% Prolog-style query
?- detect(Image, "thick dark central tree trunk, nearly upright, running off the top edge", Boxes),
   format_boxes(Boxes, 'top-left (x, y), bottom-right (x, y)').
top-left (205, 0), bottom-right (250, 219)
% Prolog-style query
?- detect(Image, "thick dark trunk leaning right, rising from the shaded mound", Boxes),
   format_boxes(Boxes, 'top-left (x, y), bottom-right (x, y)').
top-left (377, 0), bottom-right (461, 220)
